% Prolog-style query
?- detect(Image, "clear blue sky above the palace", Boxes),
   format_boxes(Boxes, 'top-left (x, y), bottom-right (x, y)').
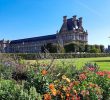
top-left (0, 0), bottom-right (110, 47)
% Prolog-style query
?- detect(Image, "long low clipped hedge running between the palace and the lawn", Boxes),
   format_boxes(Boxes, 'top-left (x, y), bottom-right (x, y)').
top-left (0, 53), bottom-right (110, 60)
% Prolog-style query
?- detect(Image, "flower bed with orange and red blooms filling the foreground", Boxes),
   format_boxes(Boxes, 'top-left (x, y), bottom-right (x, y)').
top-left (0, 55), bottom-right (110, 100)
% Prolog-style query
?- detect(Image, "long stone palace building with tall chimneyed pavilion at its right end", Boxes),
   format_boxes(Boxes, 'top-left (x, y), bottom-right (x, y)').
top-left (0, 15), bottom-right (88, 53)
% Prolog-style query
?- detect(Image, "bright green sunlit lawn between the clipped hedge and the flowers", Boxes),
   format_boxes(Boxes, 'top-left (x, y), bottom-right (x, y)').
top-left (27, 57), bottom-right (110, 71)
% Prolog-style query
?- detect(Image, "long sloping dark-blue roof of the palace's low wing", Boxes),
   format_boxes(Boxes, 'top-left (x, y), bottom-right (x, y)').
top-left (10, 34), bottom-right (56, 44)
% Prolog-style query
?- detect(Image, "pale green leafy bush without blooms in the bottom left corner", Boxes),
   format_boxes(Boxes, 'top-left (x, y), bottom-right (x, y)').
top-left (0, 79), bottom-right (41, 100)
